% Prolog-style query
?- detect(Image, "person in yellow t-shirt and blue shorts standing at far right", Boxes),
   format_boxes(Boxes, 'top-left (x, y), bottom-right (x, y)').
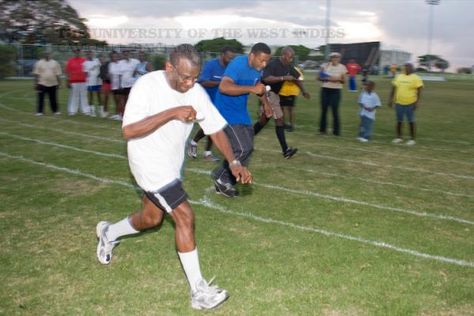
top-left (388, 63), bottom-right (423, 145)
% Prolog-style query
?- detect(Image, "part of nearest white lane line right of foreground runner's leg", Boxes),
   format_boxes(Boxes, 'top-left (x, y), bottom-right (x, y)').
top-left (195, 197), bottom-right (474, 268)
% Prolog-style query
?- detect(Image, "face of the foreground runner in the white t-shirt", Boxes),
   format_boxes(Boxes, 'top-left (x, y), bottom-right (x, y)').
top-left (166, 58), bottom-right (201, 93)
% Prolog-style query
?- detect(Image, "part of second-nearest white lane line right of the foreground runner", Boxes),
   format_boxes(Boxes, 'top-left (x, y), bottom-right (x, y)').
top-left (186, 168), bottom-right (474, 225)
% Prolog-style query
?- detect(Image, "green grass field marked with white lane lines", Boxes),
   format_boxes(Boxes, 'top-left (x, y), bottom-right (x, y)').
top-left (0, 78), bottom-right (474, 315)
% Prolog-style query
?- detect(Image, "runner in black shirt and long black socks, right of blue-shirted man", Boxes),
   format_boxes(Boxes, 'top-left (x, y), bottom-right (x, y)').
top-left (253, 47), bottom-right (309, 159)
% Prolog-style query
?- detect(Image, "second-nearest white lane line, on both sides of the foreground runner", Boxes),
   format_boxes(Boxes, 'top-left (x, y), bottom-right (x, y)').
top-left (0, 132), bottom-right (474, 225)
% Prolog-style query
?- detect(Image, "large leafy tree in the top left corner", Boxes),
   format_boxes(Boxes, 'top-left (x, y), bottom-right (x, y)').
top-left (0, 0), bottom-right (106, 45)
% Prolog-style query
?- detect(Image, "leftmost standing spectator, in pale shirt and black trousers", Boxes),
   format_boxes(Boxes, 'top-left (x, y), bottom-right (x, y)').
top-left (33, 52), bottom-right (62, 116)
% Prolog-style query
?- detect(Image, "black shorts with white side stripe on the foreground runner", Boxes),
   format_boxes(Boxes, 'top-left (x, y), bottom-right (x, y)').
top-left (145, 179), bottom-right (188, 213)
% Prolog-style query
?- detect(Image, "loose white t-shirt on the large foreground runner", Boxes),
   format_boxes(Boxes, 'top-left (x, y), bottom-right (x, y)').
top-left (122, 70), bottom-right (227, 191)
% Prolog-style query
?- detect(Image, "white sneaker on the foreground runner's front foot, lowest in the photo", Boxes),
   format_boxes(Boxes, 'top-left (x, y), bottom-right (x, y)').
top-left (191, 279), bottom-right (229, 309)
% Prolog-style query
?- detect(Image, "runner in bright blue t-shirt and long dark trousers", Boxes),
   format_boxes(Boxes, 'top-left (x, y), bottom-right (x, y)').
top-left (213, 43), bottom-right (271, 197)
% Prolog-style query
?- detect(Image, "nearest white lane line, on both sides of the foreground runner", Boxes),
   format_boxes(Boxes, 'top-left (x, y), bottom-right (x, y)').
top-left (0, 151), bottom-right (474, 268)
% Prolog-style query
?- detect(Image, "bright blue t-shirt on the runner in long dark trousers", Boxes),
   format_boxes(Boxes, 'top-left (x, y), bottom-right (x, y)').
top-left (214, 55), bottom-right (262, 125)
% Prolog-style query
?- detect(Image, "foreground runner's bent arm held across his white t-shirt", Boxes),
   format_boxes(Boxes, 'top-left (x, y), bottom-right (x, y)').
top-left (122, 105), bottom-right (196, 140)
